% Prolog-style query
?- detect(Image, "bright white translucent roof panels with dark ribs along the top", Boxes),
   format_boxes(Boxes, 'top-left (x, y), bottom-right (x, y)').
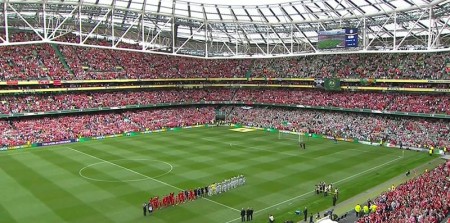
top-left (87, 0), bottom-right (443, 23)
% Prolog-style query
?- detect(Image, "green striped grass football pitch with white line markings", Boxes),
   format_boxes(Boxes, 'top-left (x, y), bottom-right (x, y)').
top-left (0, 127), bottom-right (432, 223)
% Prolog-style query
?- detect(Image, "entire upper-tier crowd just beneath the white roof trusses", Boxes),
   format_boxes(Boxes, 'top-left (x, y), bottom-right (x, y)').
top-left (0, 32), bottom-right (450, 80)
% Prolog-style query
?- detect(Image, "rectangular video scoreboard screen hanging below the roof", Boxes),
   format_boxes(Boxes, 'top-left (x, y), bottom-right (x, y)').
top-left (317, 28), bottom-right (358, 49)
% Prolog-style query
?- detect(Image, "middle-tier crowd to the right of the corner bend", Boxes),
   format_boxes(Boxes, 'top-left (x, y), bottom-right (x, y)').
top-left (234, 89), bottom-right (450, 115)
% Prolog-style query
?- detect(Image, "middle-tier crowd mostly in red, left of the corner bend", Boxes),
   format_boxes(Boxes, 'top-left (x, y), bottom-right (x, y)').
top-left (0, 89), bottom-right (234, 114)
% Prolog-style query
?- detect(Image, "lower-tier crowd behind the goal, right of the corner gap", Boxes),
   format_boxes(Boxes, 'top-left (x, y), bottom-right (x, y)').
top-left (223, 107), bottom-right (450, 148)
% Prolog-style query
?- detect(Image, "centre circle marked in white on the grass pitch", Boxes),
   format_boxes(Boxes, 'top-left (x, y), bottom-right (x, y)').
top-left (78, 159), bottom-right (173, 182)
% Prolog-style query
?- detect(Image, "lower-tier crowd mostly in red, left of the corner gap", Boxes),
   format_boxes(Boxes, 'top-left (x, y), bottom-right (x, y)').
top-left (0, 107), bottom-right (215, 146)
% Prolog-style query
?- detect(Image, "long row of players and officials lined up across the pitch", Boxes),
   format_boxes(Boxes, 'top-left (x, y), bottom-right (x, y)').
top-left (143, 175), bottom-right (246, 215)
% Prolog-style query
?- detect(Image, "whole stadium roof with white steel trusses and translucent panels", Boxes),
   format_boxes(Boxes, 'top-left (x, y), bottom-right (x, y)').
top-left (0, 0), bottom-right (450, 56)
